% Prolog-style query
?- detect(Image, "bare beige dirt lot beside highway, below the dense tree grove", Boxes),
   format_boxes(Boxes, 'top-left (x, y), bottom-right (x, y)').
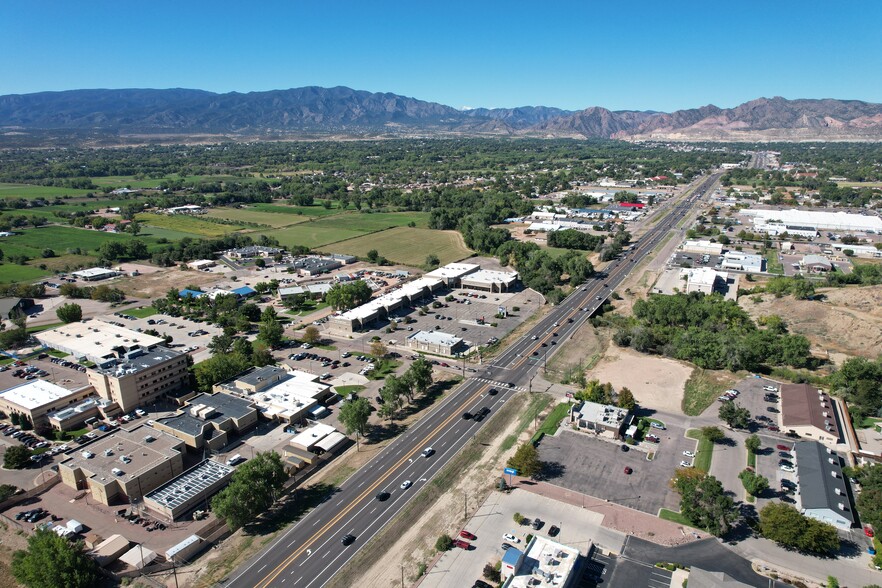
top-left (588, 344), bottom-right (692, 413)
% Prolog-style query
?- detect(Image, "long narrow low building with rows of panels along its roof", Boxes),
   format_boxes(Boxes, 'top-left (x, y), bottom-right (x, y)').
top-left (144, 459), bottom-right (234, 521)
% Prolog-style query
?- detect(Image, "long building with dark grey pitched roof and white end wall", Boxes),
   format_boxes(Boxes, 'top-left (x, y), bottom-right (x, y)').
top-left (794, 441), bottom-right (855, 530)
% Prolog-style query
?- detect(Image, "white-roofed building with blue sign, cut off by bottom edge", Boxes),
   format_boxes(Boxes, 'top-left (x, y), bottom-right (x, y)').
top-left (500, 535), bottom-right (580, 588)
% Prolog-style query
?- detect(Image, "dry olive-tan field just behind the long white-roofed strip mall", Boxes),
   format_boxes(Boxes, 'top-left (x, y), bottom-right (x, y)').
top-left (333, 227), bottom-right (472, 266)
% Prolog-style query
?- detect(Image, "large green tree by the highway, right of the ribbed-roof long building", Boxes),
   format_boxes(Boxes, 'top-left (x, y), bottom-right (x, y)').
top-left (211, 451), bottom-right (288, 530)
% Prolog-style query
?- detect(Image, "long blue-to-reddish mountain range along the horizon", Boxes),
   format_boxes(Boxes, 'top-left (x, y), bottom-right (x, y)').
top-left (0, 87), bottom-right (882, 143)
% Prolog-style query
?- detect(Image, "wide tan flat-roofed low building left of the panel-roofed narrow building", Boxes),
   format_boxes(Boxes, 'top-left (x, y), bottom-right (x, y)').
top-left (58, 425), bottom-right (184, 506)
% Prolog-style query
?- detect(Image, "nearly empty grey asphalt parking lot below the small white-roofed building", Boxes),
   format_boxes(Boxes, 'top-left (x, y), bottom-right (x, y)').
top-left (539, 425), bottom-right (696, 515)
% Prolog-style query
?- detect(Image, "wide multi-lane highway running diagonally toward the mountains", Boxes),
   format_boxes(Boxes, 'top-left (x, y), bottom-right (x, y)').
top-left (222, 174), bottom-right (720, 588)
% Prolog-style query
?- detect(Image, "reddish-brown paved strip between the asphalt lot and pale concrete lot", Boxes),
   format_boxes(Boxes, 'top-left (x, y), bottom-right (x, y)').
top-left (512, 476), bottom-right (704, 546)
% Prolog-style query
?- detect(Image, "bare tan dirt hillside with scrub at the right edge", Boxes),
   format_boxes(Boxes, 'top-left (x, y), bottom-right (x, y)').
top-left (739, 286), bottom-right (882, 358)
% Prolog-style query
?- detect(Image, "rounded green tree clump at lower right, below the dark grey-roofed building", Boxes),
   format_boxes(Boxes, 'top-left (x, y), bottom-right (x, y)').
top-left (760, 502), bottom-right (839, 555)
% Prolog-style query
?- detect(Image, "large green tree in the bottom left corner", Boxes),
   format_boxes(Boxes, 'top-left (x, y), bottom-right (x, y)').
top-left (12, 530), bottom-right (99, 588)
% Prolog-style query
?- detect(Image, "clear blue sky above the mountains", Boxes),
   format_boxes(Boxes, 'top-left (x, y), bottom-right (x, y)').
top-left (0, 0), bottom-right (882, 111)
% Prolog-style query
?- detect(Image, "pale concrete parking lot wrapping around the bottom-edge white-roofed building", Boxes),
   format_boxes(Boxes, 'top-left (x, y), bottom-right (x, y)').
top-left (420, 491), bottom-right (625, 588)
